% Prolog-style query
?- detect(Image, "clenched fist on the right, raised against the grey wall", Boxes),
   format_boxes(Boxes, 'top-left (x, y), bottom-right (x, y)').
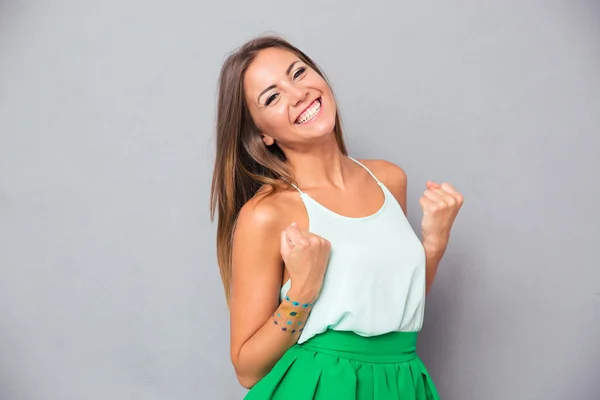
top-left (419, 181), bottom-right (464, 250)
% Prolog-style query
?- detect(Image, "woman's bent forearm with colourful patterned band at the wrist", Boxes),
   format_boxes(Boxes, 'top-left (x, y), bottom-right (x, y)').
top-left (234, 289), bottom-right (314, 388)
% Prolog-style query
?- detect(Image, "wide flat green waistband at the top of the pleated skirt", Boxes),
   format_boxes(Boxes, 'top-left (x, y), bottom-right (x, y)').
top-left (295, 330), bottom-right (419, 363)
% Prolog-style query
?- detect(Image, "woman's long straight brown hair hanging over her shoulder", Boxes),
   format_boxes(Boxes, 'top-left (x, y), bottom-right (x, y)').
top-left (210, 35), bottom-right (347, 305)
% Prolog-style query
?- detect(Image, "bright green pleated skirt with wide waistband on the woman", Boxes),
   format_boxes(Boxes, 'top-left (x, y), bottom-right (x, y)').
top-left (244, 330), bottom-right (439, 400)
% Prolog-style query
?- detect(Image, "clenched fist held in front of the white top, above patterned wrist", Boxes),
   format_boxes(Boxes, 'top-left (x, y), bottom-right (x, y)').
top-left (281, 223), bottom-right (331, 301)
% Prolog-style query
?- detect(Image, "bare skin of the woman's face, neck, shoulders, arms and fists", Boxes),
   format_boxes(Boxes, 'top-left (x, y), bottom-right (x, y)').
top-left (230, 48), bottom-right (463, 388)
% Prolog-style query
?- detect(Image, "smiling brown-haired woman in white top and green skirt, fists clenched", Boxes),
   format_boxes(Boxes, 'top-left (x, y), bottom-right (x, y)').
top-left (211, 36), bottom-right (463, 400)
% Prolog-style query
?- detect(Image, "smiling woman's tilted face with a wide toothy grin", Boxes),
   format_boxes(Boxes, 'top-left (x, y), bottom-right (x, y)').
top-left (244, 48), bottom-right (336, 147)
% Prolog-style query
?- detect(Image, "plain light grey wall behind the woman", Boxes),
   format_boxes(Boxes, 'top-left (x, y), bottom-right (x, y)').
top-left (0, 0), bottom-right (600, 400)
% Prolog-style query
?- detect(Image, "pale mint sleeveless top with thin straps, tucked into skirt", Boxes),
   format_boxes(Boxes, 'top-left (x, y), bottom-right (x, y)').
top-left (281, 157), bottom-right (425, 343)
